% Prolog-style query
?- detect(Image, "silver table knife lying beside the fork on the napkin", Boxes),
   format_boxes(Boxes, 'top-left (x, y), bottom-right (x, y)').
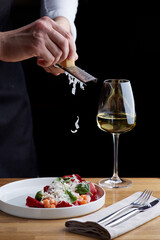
top-left (105, 198), bottom-right (160, 227)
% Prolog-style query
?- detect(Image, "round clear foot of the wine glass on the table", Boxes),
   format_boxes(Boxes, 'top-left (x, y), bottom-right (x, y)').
top-left (98, 178), bottom-right (132, 188)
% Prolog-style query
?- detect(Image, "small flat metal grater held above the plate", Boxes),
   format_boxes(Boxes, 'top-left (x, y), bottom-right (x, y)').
top-left (56, 63), bottom-right (98, 83)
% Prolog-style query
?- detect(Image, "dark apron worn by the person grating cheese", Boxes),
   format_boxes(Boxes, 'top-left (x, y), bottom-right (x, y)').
top-left (0, 0), bottom-right (38, 177)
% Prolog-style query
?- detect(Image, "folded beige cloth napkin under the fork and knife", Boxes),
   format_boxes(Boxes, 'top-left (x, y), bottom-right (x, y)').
top-left (65, 192), bottom-right (160, 240)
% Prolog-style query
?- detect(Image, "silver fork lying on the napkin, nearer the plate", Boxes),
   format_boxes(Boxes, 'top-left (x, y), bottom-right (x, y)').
top-left (97, 189), bottom-right (153, 224)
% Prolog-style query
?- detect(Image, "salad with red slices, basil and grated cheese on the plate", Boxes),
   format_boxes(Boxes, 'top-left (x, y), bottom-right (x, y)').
top-left (26, 174), bottom-right (97, 208)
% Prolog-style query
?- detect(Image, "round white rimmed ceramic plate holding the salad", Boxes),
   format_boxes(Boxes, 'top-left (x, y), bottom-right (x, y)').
top-left (0, 178), bottom-right (105, 219)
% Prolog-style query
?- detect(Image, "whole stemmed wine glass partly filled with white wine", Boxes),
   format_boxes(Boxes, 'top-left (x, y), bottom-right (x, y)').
top-left (97, 79), bottom-right (136, 188)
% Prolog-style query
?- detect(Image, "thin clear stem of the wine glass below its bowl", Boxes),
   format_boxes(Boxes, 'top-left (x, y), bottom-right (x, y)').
top-left (111, 133), bottom-right (121, 182)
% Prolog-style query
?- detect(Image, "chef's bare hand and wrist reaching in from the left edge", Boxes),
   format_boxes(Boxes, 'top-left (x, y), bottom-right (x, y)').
top-left (0, 17), bottom-right (78, 75)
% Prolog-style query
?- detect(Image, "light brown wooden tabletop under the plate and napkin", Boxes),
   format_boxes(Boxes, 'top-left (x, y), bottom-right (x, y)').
top-left (0, 178), bottom-right (160, 240)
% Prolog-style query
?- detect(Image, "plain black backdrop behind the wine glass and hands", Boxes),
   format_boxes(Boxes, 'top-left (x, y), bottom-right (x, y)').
top-left (12, 0), bottom-right (160, 177)
